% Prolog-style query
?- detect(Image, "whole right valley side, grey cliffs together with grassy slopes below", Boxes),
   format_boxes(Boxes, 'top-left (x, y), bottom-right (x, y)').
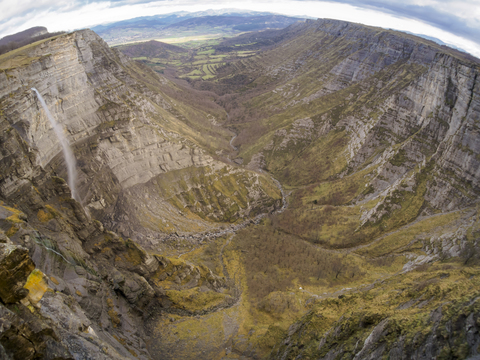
top-left (210, 20), bottom-right (480, 233)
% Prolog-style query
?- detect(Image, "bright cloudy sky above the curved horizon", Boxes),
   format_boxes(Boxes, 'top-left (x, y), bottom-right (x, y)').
top-left (0, 0), bottom-right (480, 58)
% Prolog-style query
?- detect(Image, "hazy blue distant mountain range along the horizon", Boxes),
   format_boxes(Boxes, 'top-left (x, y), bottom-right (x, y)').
top-left (92, 10), bottom-right (303, 45)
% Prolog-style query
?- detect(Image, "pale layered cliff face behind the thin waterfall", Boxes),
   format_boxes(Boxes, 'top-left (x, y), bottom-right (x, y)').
top-left (0, 31), bottom-right (282, 242)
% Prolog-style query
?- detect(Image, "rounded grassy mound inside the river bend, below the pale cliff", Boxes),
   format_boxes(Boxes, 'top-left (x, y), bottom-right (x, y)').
top-left (132, 166), bottom-right (281, 233)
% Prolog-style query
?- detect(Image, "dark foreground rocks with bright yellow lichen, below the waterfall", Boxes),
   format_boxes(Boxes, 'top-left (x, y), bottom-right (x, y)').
top-left (0, 200), bottom-right (154, 359)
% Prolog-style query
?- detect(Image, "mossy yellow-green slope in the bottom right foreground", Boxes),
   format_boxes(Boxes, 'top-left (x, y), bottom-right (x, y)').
top-left (270, 263), bottom-right (478, 359)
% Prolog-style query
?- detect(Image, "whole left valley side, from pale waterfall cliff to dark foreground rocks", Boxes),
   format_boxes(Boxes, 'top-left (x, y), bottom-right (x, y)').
top-left (0, 30), bottom-right (282, 359)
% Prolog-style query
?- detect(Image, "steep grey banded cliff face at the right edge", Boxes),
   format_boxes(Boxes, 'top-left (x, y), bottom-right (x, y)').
top-left (330, 36), bottom-right (480, 221)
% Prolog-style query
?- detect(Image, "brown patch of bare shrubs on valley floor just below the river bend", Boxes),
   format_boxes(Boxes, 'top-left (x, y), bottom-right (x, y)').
top-left (234, 225), bottom-right (361, 304)
